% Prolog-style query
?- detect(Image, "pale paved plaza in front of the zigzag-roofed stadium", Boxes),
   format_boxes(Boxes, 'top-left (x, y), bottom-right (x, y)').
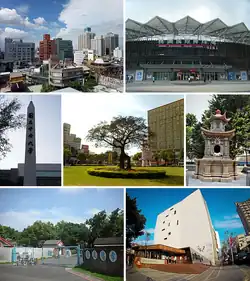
top-left (126, 81), bottom-right (250, 93)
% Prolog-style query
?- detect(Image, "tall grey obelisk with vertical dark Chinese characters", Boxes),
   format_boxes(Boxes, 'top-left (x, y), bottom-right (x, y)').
top-left (23, 101), bottom-right (37, 186)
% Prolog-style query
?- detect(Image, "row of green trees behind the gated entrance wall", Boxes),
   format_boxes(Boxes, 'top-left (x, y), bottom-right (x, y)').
top-left (0, 209), bottom-right (123, 247)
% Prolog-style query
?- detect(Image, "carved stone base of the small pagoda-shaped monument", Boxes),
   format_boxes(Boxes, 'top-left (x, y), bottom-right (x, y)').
top-left (192, 158), bottom-right (239, 182)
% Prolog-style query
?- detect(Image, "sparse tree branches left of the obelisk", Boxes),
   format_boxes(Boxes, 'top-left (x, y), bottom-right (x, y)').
top-left (0, 96), bottom-right (25, 159)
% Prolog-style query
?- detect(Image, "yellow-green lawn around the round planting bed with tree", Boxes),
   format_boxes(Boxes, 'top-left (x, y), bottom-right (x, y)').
top-left (64, 166), bottom-right (184, 186)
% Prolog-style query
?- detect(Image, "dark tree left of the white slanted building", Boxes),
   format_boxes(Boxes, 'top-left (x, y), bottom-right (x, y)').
top-left (126, 194), bottom-right (146, 247)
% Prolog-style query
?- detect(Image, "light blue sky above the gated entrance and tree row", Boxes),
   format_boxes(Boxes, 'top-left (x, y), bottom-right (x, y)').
top-left (0, 188), bottom-right (124, 231)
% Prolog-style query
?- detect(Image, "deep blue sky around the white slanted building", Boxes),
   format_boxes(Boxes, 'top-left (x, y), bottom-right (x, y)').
top-left (126, 188), bottom-right (250, 244)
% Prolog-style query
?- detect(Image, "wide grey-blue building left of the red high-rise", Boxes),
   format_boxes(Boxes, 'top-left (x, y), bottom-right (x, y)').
top-left (4, 38), bottom-right (35, 64)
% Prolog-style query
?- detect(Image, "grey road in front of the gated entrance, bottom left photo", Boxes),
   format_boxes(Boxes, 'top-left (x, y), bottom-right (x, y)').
top-left (0, 265), bottom-right (87, 281)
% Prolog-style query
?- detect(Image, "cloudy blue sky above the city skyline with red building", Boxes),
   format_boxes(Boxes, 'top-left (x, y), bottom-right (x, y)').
top-left (0, 0), bottom-right (123, 48)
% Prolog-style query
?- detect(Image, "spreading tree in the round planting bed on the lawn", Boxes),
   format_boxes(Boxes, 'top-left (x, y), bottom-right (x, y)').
top-left (87, 116), bottom-right (149, 169)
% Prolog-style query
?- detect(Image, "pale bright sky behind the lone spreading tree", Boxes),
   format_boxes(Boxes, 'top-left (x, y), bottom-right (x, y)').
top-left (62, 93), bottom-right (183, 155)
